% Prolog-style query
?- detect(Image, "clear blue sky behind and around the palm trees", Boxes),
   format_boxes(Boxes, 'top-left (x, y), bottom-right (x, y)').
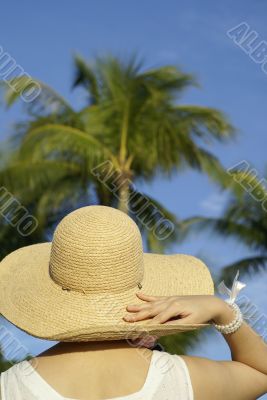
top-left (0, 0), bottom-right (267, 396)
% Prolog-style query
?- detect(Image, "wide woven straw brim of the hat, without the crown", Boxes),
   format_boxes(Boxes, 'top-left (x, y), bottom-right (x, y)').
top-left (0, 243), bottom-right (214, 341)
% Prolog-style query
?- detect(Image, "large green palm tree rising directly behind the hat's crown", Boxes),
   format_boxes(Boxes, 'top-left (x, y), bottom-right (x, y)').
top-left (0, 56), bottom-right (233, 250)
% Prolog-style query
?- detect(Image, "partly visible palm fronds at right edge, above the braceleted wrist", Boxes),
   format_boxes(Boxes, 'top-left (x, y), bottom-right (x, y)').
top-left (184, 167), bottom-right (267, 284)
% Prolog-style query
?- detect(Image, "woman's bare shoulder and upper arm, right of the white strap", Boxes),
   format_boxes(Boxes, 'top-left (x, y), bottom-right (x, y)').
top-left (180, 356), bottom-right (267, 400)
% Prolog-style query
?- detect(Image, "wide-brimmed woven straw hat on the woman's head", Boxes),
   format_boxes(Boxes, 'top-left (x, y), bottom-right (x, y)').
top-left (0, 206), bottom-right (214, 341)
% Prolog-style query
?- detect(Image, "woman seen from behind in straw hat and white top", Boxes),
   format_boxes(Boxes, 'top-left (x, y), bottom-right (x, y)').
top-left (0, 206), bottom-right (267, 400)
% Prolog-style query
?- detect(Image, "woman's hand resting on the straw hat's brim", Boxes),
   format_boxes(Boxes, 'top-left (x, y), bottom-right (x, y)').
top-left (124, 292), bottom-right (230, 324)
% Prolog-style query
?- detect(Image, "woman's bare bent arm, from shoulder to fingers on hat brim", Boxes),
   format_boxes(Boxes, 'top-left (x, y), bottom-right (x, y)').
top-left (125, 293), bottom-right (267, 400)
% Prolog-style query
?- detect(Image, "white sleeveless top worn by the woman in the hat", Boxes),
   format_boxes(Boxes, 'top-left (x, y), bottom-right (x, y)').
top-left (0, 350), bottom-right (193, 400)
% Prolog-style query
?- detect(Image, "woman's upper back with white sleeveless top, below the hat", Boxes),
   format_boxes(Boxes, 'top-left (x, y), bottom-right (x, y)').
top-left (1, 348), bottom-right (193, 400)
